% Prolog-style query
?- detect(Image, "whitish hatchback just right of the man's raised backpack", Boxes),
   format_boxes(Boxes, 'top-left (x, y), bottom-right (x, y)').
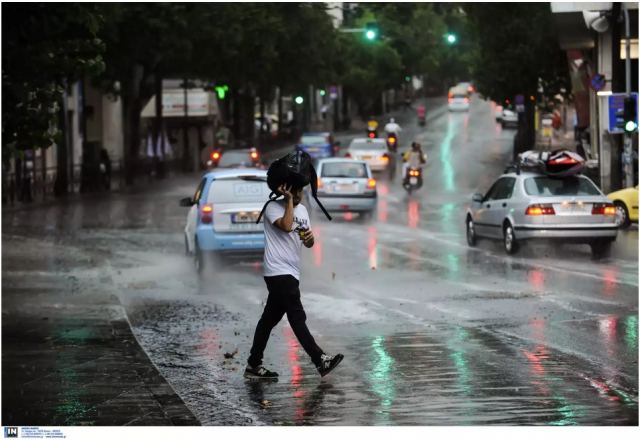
top-left (316, 158), bottom-right (378, 215)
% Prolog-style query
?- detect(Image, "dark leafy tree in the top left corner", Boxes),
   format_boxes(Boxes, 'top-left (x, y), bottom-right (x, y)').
top-left (2, 3), bottom-right (104, 194)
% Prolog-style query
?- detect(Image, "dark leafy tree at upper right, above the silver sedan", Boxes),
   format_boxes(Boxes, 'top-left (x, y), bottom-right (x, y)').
top-left (464, 3), bottom-right (569, 154)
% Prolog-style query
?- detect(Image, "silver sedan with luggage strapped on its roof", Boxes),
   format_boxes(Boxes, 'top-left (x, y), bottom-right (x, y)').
top-left (466, 171), bottom-right (618, 257)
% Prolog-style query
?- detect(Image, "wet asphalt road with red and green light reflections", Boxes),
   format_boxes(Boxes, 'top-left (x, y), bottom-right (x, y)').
top-left (3, 98), bottom-right (638, 425)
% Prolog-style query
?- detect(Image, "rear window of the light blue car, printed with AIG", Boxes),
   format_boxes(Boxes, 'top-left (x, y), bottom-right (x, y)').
top-left (207, 176), bottom-right (270, 204)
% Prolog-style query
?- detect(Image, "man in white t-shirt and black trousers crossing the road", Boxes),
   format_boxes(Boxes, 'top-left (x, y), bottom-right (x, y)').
top-left (244, 185), bottom-right (344, 380)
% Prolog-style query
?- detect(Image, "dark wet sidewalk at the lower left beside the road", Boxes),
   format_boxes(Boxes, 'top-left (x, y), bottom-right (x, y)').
top-left (2, 234), bottom-right (199, 426)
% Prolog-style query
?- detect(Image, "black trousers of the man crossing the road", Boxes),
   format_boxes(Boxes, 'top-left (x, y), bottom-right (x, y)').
top-left (248, 275), bottom-right (324, 367)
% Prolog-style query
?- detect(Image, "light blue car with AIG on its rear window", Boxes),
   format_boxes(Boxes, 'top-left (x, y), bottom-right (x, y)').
top-left (180, 168), bottom-right (271, 273)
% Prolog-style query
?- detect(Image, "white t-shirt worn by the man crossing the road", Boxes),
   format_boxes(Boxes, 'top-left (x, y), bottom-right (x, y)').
top-left (264, 201), bottom-right (311, 280)
